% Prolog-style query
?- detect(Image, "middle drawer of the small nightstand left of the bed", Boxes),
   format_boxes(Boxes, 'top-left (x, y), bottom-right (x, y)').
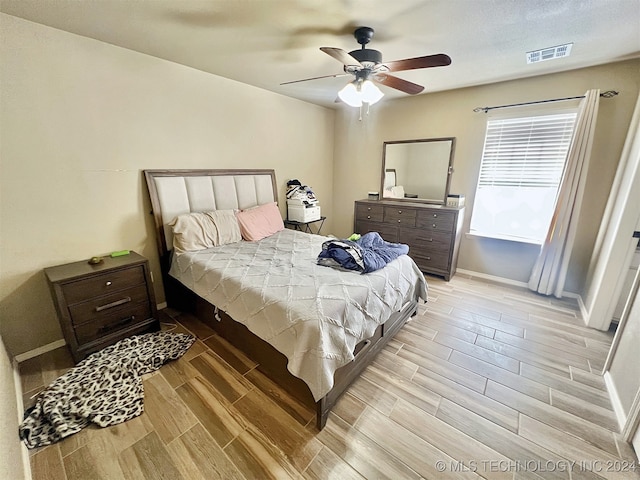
top-left (69, 285), bottom-right (149, 325)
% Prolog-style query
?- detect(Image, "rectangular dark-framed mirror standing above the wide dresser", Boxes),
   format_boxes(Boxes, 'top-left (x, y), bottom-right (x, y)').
top-left (381, 137), bottom-right (456, 205)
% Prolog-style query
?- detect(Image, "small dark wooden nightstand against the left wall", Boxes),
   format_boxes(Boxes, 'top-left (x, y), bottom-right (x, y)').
top-left (44, 252), bottom-right (159, 362)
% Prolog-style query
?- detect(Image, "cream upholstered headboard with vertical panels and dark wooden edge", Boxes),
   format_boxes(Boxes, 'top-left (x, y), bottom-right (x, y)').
top-left (144, 169), bottom-right (278, 258)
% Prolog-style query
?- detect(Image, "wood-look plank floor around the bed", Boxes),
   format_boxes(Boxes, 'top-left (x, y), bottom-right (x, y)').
top-left (21, 275), bottom-right (640, 480)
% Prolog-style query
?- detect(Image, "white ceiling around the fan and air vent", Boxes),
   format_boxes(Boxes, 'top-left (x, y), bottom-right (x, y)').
top-left (0, 0), bottom-right (640, 107)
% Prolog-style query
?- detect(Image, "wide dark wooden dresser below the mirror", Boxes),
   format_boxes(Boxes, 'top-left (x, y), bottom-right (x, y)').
top-left (354, 200), bottom-right (464, 281)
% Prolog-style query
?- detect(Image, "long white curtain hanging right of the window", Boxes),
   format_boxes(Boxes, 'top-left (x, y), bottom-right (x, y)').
top-left (529, 90), bottom-right (600, 298)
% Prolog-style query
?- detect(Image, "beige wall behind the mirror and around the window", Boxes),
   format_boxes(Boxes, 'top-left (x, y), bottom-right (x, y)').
top-left (334, 60), bottom-right (640, 293)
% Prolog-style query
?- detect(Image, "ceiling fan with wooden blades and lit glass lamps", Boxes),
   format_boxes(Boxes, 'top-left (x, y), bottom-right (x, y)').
top-left (280, 27), bottom-right (451, 107)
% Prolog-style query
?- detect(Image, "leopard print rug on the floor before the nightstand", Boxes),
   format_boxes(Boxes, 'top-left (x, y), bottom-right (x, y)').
top-left (19, 332), bottom-right (195, 448)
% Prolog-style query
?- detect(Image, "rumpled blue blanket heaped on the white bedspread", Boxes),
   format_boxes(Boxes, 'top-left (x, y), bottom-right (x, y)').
top-left (318, 232), bottom-right (409, 273)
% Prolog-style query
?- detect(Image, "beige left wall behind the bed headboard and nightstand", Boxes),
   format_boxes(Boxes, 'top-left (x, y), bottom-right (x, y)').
top-left (0, 14), bottom-right (334, 355)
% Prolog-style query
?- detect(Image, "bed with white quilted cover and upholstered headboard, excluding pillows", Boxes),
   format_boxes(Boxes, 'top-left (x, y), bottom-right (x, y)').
top-left (144, 169), bottom-right (427, 429)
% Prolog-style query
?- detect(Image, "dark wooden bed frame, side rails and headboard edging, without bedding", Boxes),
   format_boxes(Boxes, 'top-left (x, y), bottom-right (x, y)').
top-left (144, 170), bottom-right (417, 430)
